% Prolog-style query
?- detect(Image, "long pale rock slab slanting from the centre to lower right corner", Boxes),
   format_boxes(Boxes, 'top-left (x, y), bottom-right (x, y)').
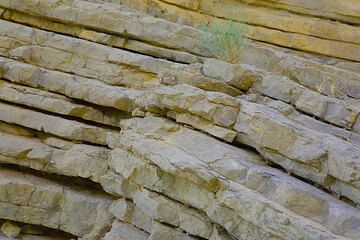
top-left (118, 117), bottom-right (359, 237)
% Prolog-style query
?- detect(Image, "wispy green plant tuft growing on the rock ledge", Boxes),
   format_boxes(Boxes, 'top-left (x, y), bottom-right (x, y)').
top-left (201, 19), bottom-right (247, 63)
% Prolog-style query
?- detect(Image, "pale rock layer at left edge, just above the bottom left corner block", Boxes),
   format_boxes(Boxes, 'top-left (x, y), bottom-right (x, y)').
top-left (0, 129), bottom-right (109, 182)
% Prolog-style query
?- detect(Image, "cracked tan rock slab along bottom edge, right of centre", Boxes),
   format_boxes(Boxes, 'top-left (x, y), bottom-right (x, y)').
top-left (207, 184), bottom-right (349, 239)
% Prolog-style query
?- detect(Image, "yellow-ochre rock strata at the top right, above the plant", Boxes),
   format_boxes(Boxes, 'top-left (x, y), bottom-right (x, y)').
top-left (115, 0), bottom-right (360, 62)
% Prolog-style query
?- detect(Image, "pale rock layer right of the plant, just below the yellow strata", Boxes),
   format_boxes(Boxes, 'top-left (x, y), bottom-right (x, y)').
top-left (242, 42), bottom-right (360, 99)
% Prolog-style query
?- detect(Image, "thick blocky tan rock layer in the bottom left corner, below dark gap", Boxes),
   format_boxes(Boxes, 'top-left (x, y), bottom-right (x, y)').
top-left (0, 169), bottom-right (112, 239)
